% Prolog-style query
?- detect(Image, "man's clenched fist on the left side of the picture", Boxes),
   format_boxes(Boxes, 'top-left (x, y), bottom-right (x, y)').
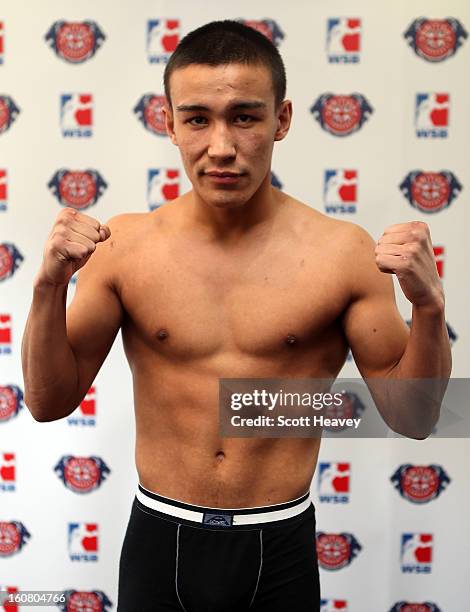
top-left (36, 208), bottom-right (111, 285)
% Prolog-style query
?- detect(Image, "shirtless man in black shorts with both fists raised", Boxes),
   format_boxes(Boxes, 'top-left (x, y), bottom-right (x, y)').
top-left (22, 22), bottom-right (451, 612)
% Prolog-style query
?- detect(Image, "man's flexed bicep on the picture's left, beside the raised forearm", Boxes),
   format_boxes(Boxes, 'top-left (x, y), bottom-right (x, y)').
top-left (66, 233), bottom-right (123, 405)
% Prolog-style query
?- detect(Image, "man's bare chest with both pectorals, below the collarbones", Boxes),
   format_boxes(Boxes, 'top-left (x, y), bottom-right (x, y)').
top-left (120, 234), bottom-right (349, 358)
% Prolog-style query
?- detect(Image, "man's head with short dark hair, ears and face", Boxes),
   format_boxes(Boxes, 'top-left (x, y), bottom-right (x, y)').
top-left (164, 21), bottom-right (292, 208)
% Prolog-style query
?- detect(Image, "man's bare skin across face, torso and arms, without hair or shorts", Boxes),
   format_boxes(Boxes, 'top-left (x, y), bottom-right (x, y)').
top-left (23, 64), bottom-right (450, 508)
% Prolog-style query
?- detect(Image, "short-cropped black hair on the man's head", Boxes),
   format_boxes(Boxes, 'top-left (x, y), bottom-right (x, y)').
top-left (163, 19), bottom-right (286, 107)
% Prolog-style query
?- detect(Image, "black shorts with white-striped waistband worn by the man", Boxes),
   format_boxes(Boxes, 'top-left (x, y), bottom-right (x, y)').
top-left (117, 485), bottom-right (320, 612)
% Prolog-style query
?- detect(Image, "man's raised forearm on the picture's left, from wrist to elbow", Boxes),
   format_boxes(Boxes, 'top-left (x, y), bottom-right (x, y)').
top-left (21, 282), bottom-right (78, 421)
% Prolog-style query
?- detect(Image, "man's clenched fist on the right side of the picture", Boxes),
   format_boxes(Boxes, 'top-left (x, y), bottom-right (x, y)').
top-left (375, 221), bottom-right (444, 308)
